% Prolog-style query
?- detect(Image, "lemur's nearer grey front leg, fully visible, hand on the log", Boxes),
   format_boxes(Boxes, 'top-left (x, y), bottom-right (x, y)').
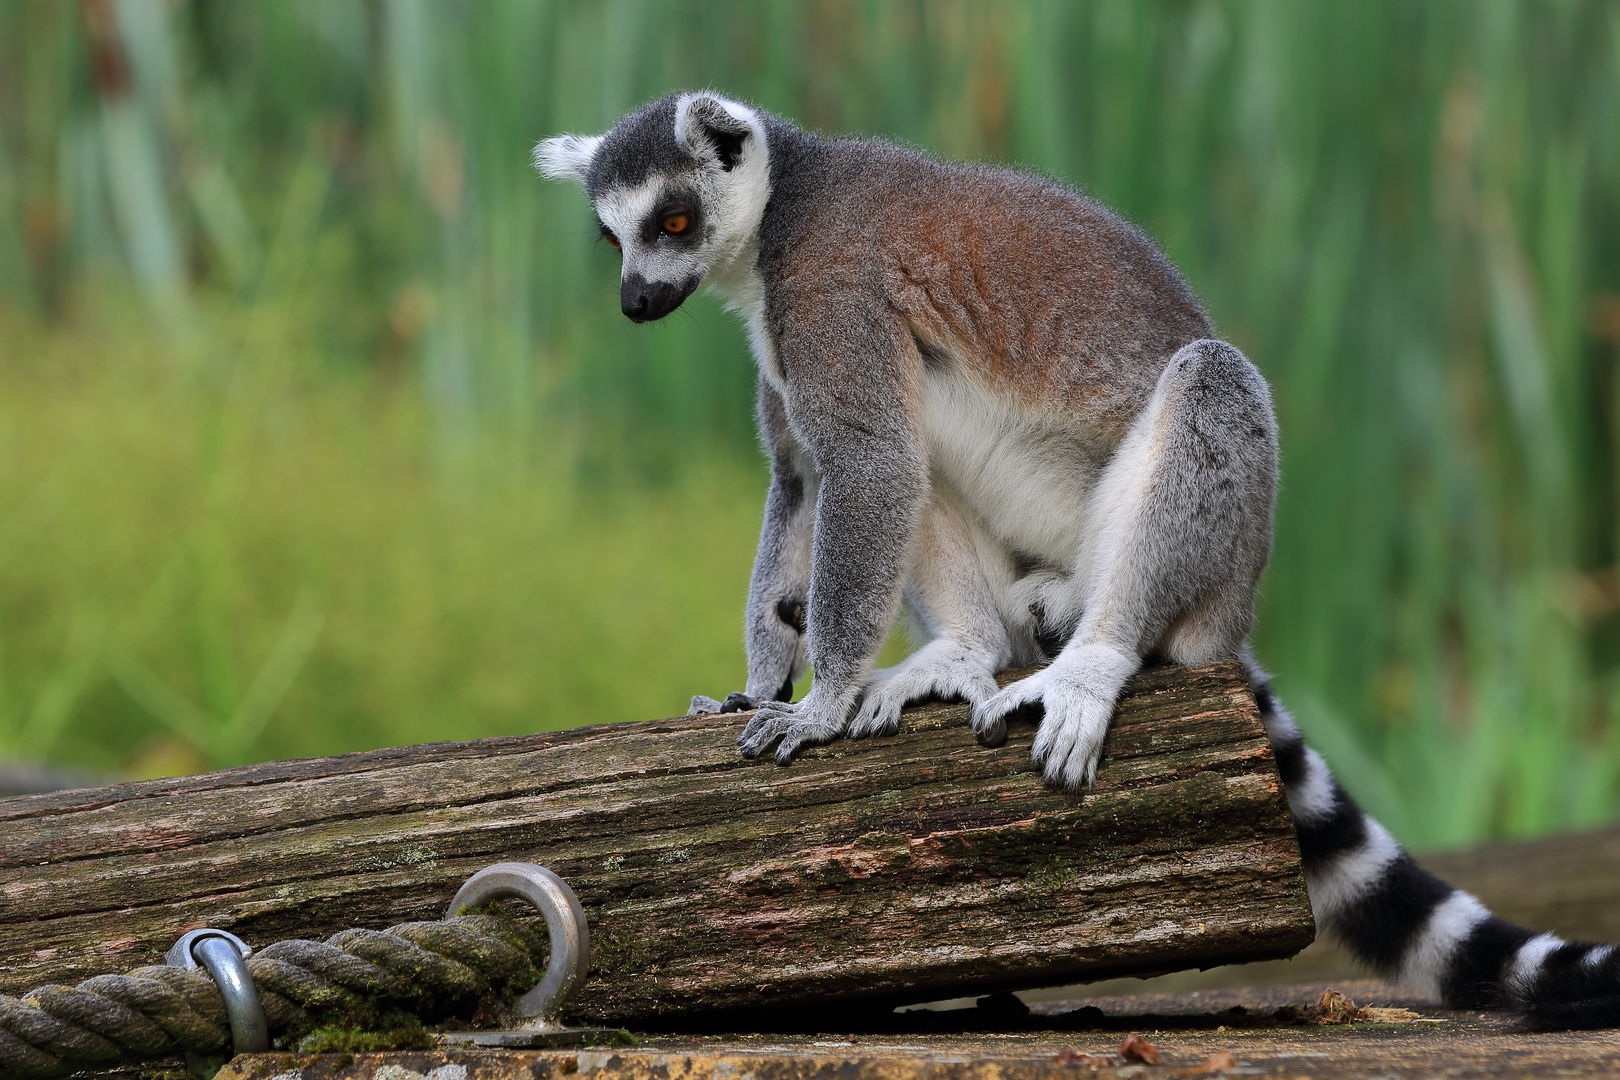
top-left (737, 317), bottom-right (928, 764)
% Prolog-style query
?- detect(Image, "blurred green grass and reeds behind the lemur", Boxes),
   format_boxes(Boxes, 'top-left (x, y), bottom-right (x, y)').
top-left (0, 0), bottom-right (1620, 847)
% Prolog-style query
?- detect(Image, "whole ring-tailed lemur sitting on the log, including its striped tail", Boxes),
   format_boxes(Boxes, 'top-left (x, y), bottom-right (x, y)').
top-left (535, 92), bottom-right (1620, 1027)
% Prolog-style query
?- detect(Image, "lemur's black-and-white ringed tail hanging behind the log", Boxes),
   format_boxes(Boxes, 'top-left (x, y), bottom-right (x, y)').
top-left (1249, 662), bottom-right (1620, 1030)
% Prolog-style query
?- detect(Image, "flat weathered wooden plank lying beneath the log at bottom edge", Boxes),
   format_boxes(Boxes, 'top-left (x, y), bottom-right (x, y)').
top-left (219, 983), bottom-right (1620, 1080)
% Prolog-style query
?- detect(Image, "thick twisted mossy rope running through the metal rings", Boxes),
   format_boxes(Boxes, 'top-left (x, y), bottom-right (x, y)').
top-left (0, 915), bottom-right (546, 1077)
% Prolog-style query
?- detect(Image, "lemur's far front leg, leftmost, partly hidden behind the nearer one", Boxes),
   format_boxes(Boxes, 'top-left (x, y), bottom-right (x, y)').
top-left (689, 379), bottom-right (816, 716)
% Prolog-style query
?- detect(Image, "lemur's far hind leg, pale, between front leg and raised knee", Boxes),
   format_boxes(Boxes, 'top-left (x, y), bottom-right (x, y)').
top-left (849, 481), bottom-right (1014, 738)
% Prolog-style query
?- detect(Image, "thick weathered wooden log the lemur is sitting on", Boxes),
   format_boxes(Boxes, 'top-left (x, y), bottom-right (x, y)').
top-left (0, 664), bottom-right (1314, 1027)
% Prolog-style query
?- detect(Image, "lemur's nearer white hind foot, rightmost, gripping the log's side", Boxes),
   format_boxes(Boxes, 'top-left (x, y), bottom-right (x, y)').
top-left (974, 644), bottom-right (1140, 792)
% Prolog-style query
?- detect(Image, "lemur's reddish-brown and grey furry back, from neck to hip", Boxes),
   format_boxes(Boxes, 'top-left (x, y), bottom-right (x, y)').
top-left (760, 125), bottom-right (1213, 434)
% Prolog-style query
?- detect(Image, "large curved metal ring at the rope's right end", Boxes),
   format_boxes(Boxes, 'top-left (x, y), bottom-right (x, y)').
top-left (444, 863), bottom-right (591, 1031)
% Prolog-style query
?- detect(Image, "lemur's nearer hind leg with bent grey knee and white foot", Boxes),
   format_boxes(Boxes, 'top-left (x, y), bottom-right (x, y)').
top-left (975, 340), bottom-right (1277, 790)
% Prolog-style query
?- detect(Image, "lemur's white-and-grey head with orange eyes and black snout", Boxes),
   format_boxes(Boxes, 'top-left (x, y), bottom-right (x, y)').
top-left (535, 92), bottom-right (771, 322)
